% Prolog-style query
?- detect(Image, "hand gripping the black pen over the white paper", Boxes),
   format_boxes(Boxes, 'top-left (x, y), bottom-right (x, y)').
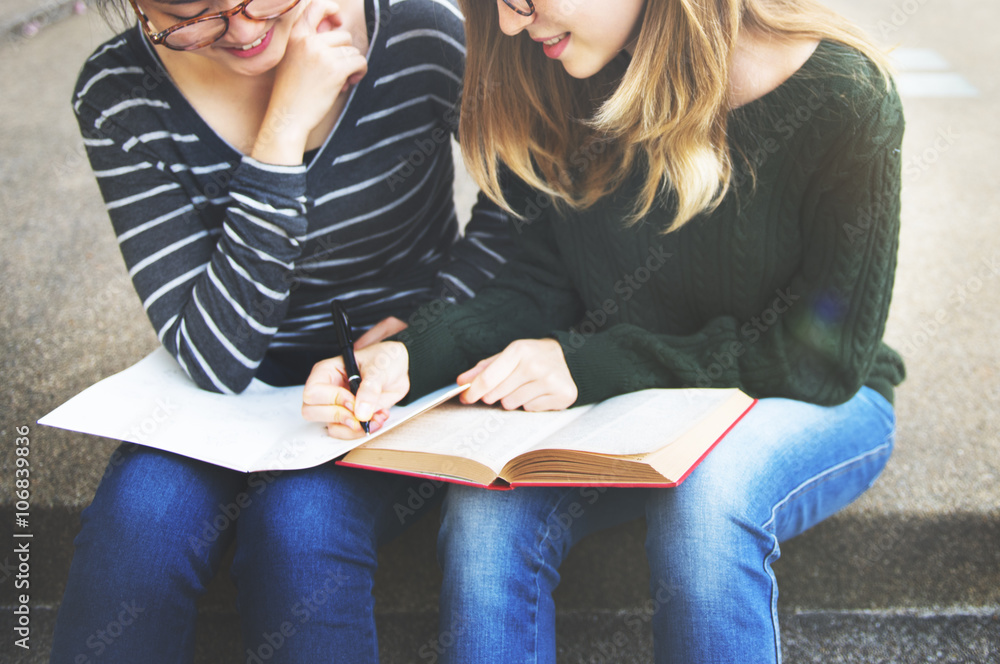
top-left (302, 341), bottom-right (410, 440)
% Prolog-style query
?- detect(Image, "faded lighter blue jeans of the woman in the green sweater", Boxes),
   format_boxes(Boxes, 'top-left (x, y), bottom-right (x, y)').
top-left (438, 388), bottom-right (895, 664)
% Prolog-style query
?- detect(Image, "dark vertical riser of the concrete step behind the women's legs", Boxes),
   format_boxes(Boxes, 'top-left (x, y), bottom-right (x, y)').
top-left (0, 508), bottom-right (1000, 612)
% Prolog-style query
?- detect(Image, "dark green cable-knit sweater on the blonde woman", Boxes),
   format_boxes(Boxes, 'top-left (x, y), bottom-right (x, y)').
top-left (398, 42), bottom-right (904, 405)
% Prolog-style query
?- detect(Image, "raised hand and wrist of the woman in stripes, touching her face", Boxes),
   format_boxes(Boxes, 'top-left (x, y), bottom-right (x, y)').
top-left (251, 0), bottom-right (368, 165)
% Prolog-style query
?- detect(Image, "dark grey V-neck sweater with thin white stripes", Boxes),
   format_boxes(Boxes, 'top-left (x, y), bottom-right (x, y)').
top-left (73, 0), bottom-right (511, 393)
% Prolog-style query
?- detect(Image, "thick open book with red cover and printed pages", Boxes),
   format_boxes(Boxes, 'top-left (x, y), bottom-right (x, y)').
top-left (338, 389), bottom-right (755, 488)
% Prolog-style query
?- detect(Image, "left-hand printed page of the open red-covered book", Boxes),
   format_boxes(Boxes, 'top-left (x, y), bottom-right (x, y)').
top-left (362, 402), bottom-right (592, 473)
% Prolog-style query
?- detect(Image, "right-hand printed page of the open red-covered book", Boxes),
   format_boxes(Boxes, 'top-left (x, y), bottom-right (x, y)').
top-left (530, 389), bottom-right (737, 455)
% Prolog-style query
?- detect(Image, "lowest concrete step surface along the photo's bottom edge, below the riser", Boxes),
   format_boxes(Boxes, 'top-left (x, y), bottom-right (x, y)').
top-left (0, 609), bottom-right (1000, 664)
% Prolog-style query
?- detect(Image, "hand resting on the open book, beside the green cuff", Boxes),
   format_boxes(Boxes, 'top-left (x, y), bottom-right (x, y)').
top-left (457, 339), bottom-right (577, 412)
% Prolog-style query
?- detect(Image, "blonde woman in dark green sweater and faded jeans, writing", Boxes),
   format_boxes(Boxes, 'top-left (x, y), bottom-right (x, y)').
top-left (303, 0), bottom-right (903, 663)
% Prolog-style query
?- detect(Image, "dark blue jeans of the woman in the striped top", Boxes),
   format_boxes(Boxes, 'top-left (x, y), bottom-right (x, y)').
top-left (51, 445), bottom-right (442, 664)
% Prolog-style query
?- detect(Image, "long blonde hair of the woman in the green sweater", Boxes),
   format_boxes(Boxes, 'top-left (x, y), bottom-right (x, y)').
top-left (459, 0), bottom-right (890, 232)
